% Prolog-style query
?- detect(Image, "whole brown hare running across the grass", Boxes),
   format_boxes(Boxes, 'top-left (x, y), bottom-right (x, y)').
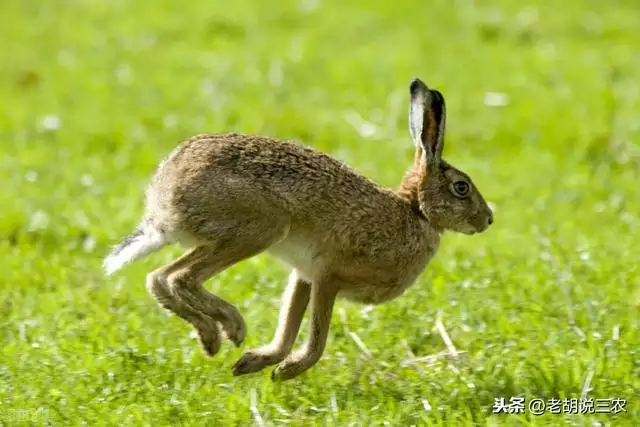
top-left (104, 79), bottom-right (493, 380)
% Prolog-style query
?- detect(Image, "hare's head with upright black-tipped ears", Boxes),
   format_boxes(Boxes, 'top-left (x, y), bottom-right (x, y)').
top-left (409, 79), bottom-right (493, 234)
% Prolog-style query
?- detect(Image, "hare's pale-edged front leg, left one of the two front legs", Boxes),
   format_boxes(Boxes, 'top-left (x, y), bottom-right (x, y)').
top-left (233, 270), bottom-right (311, 375)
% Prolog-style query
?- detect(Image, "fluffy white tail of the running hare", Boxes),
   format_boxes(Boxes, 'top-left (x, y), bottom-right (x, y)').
top-left (102, 226), bottom-right (169, 276)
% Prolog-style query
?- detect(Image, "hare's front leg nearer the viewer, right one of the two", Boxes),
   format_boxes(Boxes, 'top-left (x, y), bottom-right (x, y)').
top-left (271, 280), bottom-right (338, 381)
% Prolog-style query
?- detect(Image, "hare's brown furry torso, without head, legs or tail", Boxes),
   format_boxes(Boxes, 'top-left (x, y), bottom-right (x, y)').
top-left (148, 133), bottom-right (439, 303)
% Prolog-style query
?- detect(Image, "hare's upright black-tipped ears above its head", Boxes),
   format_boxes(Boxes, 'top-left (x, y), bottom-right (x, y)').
top-left (409, 79), bottom-right (446, 162)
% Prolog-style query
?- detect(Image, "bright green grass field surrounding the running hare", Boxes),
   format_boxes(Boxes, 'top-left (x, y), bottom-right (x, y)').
top-left (0, 0), bottom-right (640, 426)
